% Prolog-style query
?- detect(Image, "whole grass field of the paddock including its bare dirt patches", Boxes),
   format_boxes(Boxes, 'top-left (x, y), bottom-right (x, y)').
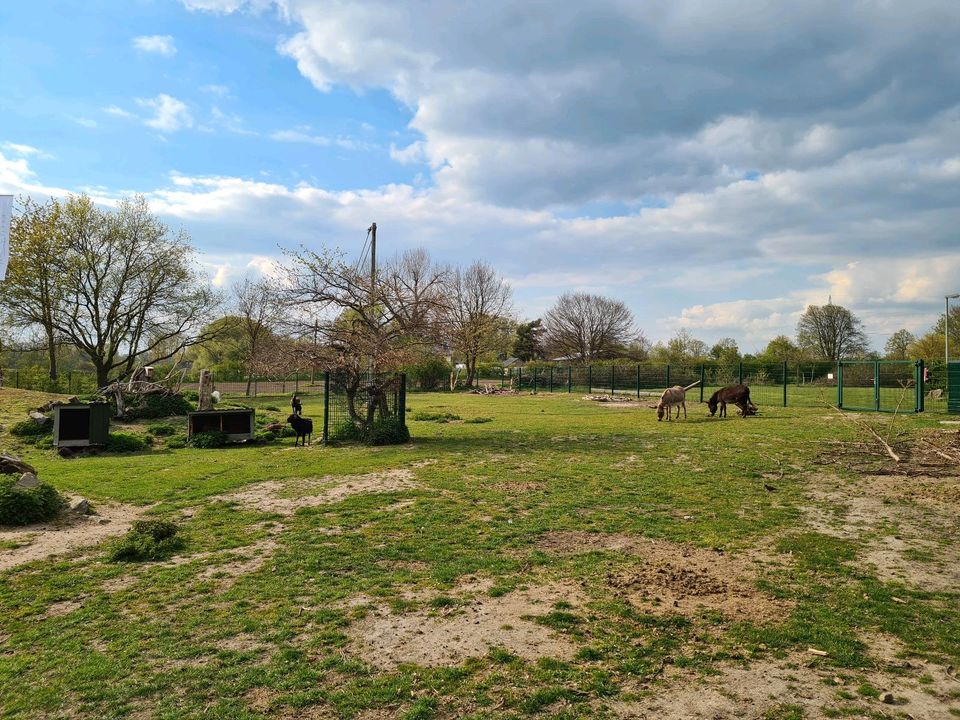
top-left (0, 390), bottom-right (960, 719)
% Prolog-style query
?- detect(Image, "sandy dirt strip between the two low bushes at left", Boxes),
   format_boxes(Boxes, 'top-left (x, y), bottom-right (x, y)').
top-left (0, 503), bottom-right (146, 570)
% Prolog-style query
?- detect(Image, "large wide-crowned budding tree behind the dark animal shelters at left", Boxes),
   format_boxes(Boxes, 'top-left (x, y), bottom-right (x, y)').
top-left (53, 196), bottom-right (219, 386)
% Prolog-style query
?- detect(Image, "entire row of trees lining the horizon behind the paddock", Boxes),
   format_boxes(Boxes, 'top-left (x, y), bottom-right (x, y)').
top-left (0, 195), bottom-right (960, 396)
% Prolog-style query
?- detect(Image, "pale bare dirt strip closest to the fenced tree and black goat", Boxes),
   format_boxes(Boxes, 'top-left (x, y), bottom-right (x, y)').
top-left (212, 469), bottom-right (418, 515)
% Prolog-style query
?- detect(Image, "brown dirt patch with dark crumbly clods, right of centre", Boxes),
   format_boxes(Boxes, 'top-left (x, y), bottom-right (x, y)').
top-left (537, 531), bottom-right (791, 622)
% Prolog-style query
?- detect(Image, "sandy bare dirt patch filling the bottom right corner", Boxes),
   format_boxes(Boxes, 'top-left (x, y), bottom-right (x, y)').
top-left (608, 653), bottom-right (960, 720)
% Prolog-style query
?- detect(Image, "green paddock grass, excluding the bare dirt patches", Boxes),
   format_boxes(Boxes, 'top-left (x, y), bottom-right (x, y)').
top-left (0, 391), bottom-right (960, 718)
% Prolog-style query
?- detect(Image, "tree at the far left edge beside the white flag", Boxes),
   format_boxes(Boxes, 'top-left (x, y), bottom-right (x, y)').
top-left (0, 198), bottom-right (66, 380)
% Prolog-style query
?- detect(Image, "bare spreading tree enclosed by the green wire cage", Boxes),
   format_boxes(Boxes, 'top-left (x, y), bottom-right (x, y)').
top-left (286, 249), bottom-right (446, 429)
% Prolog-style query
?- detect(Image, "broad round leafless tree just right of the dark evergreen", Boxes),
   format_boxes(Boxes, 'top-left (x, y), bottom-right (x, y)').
top-left (543, 293), bottom-right (642, 362)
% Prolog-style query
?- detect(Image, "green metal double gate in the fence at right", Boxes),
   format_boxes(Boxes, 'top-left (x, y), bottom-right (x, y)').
top-left (837, 360), bottom-right (928, 412)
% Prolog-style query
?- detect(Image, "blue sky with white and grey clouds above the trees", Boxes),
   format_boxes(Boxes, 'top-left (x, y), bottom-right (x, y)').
top-left (0, 0), bottom-right (960, 351)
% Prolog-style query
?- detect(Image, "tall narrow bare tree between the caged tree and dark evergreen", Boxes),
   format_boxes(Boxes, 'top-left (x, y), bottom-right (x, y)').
top-left (446, 261), bottom-right (513, 387)
